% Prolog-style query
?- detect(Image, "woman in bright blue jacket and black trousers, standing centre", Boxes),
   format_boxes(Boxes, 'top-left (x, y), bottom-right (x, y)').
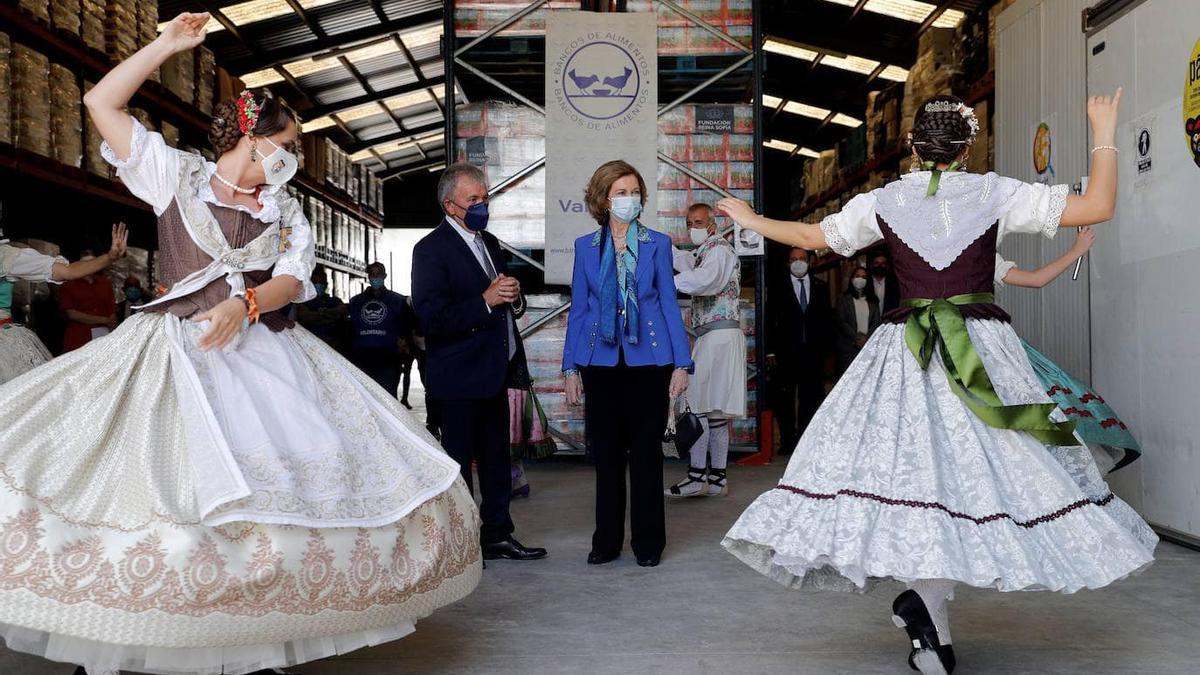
top-left (563, 160), bottom-right (692, 567)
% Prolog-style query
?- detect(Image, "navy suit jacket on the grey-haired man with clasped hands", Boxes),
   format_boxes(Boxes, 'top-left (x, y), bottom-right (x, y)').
top-left (413, 220), bottom-right (524, 400)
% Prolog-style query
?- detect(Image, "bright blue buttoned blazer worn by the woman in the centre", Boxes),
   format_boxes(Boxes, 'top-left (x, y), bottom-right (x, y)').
top-left (563, 225), bottom-right (692, 371)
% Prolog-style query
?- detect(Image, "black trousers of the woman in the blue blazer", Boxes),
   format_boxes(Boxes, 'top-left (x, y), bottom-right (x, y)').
top-left (582, 364), bottom-right (672, 557)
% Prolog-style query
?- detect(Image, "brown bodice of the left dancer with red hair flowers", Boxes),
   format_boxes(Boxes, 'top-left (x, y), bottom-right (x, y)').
top-left (146, 201), bottom-right (295, 331)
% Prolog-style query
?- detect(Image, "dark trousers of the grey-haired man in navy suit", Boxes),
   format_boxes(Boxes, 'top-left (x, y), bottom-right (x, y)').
top-left (437, 389), bottom-right (512, 544)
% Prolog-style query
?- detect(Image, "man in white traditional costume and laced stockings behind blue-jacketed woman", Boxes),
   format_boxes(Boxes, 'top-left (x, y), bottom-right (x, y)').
top-left (666, 199), bottom-right (746, 497)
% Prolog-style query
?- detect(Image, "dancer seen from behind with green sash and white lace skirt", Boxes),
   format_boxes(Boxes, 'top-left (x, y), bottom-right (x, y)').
top-left (718, 92), bottom-right (1157, 674)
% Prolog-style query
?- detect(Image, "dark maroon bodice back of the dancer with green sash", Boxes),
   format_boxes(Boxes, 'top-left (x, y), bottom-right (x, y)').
top-left (876, 216), bottom-right (1012, 323)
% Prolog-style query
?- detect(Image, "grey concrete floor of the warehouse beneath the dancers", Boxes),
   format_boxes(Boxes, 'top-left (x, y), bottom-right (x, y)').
top-left (0, 454), bottom-right (1200, 675)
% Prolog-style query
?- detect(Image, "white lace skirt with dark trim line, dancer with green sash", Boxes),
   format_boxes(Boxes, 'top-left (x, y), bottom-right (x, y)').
top-left (722, 319), bottom-right (1158, 592)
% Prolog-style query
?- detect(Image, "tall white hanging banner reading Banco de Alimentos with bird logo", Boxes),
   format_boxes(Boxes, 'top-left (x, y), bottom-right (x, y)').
top-left (546, 12), bottom-right (659, 283)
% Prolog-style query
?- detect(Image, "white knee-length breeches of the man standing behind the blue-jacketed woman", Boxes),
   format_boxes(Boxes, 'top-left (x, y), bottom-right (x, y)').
top-left (688, 328), bottom-right (746, 417)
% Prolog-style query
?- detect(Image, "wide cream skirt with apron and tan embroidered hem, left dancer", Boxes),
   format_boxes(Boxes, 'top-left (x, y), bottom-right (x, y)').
top-left (0, 313), bottom-right (480, 674)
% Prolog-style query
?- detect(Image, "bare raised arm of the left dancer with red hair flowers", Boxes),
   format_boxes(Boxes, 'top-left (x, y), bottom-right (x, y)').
top-left (83, 13), bottom-right (209, 161)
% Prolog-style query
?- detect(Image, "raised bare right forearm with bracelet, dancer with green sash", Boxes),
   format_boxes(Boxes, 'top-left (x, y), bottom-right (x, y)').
top-left (1062, 89), bottom-right (1121, 227)
